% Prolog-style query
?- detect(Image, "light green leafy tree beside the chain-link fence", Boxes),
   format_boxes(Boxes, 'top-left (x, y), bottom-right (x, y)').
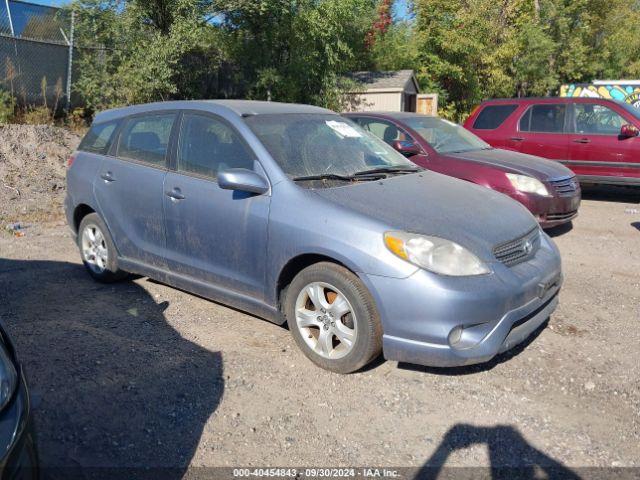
top-left (70, 0), bottom-right (223, 110)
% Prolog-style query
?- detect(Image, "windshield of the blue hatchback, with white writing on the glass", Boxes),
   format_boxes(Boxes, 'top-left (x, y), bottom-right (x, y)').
top-left (245, 113), bottom-right (417, 178)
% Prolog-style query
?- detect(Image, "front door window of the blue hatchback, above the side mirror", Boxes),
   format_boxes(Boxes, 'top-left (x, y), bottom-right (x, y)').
top-left (177, 113), bottom-right (254, 178)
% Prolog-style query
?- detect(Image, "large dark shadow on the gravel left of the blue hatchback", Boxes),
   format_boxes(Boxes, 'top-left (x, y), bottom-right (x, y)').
top-left (0, 259), bottom-right (224, 480)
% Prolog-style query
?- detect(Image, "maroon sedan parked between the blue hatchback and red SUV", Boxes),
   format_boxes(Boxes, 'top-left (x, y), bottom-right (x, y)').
top-left (343, 112), bottom-right (581, 228)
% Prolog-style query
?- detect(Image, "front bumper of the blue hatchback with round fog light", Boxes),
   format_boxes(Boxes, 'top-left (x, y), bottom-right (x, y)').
top-left (365, 235), bottom-right (562, 367)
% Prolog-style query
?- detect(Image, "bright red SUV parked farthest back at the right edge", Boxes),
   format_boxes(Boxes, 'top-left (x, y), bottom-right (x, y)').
top-left (464, 98), bottom-right (640, 186)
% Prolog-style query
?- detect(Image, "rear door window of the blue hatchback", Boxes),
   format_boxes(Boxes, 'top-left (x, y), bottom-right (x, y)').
top-left (118, 113), bottom-right (176, 167)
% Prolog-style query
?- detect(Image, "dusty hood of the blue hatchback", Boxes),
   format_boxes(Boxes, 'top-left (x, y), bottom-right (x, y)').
top-left (315, 171), bottom-right (537, 261)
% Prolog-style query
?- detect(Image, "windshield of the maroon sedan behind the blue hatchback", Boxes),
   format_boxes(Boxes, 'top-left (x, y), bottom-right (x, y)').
top-left (402, 117), bottom-right (491, 153)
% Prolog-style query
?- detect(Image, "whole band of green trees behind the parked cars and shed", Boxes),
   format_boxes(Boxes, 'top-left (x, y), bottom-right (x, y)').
top-left (70, 0), bottom-right (640, 120)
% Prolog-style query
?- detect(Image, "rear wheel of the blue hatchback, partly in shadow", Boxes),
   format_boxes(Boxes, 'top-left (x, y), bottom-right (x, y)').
top-left (78, 213), bottom-right (128, 283)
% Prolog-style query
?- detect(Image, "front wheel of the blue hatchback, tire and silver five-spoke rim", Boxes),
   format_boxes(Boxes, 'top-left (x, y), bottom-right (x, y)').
top-left (283, 262), bottom-right (382, 373)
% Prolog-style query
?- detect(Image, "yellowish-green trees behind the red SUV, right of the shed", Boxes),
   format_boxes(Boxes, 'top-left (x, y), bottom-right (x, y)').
top-left (415, 0), bottom-right (640, 119)
